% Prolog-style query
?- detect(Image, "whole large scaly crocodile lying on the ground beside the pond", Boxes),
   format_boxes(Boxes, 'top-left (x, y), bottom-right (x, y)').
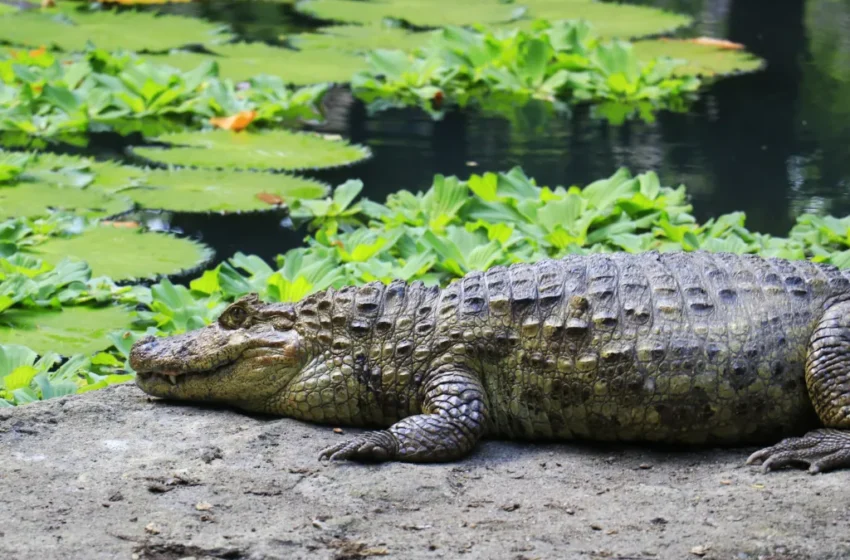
top-left (130, 251), bottom-right (850, 473)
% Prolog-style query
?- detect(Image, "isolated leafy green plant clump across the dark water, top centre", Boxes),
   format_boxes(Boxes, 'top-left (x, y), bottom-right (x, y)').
top-left (352, 21), bottom-right (700, 120)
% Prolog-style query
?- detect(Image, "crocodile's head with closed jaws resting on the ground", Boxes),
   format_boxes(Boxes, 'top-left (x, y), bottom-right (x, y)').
top-left (130, 294), bottom-right (305, 411)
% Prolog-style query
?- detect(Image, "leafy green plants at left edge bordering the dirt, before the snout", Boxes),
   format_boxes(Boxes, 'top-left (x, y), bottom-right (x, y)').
top-left (0, 344), bottom-right (133, 407)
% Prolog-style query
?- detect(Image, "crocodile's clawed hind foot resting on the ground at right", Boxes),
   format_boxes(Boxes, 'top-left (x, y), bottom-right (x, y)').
top-left (747, 429), bottom-right (850, 474)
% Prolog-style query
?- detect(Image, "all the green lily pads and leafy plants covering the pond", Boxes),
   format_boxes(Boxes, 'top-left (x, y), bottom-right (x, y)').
top-left (0, 0), bottom-right (828, 406)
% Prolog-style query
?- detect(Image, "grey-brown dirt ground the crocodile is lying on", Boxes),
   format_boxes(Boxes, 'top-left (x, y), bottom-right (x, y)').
top-left (0, 385), bottom-right (850, 560)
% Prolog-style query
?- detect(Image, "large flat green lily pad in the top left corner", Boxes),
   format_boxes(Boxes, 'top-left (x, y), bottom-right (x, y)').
top-left (0, 9), bottom-right (226, 51)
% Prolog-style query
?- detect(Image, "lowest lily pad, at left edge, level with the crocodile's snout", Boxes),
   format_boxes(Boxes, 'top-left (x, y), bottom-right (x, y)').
top-left (0, 305), bottom-right (132, 356)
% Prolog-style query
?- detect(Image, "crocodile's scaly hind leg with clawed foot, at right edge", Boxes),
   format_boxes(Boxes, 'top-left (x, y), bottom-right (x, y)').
top-left (747, 302), bottom-right (850, 473)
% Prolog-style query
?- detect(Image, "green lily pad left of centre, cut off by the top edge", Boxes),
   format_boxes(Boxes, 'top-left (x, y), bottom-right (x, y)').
top-left (295, 0), bottom-right (522, 27)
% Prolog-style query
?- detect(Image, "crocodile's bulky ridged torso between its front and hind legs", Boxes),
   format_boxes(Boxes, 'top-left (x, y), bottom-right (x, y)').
top-left (435, 252), bottom-right (850, 443)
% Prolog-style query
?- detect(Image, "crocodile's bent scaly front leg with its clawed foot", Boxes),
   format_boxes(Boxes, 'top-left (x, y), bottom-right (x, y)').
top-left (319, 366), bottom-right (487, 463)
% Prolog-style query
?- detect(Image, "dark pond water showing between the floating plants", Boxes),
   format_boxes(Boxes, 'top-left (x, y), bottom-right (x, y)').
top-left (136, 0), bottom-right (850, 266)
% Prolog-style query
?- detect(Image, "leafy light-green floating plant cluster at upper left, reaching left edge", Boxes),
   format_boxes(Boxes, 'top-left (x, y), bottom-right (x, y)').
top-left (0, 49), bottom-right (327, 137)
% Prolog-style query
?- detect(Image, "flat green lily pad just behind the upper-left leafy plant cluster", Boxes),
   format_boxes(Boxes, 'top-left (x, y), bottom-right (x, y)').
top-left (151, 43), bottom-right (366, 85)
